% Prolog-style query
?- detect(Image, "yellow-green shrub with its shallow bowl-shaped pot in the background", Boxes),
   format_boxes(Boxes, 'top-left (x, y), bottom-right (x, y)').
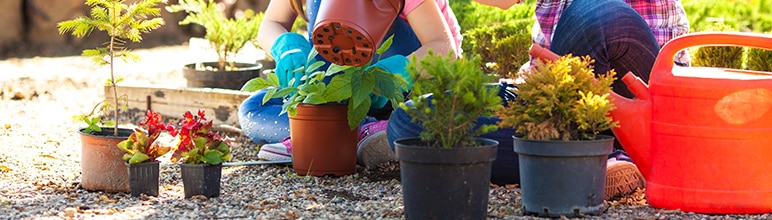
top-left (166, 0), bottom-right (263, 90)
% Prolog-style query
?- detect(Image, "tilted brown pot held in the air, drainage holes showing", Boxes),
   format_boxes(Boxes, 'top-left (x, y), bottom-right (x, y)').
top-left (312, 0), bottom-right (404, 66)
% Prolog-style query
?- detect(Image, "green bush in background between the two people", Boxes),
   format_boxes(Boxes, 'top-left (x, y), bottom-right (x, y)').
top-left (462, 19), bottom-right (533, 77)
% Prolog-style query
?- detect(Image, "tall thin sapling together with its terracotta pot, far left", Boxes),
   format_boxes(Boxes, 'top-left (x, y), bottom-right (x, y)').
top-left (57, 0), bottom-right (166, 192)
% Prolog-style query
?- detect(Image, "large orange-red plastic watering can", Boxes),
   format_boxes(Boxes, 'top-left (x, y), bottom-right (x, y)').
top-left (532, 32), bottom-right (772, 214)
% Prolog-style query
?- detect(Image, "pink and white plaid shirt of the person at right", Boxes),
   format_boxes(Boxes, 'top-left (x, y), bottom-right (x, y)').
top-left (531, 0), bottom-right (690, 65)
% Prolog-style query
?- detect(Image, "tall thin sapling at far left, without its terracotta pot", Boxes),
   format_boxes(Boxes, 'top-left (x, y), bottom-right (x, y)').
top-left (57, 0), bottom-right (166, 136)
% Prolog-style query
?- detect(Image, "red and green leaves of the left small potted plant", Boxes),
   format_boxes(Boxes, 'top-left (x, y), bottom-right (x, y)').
top-left (118, 110), bottom-right (177, 164)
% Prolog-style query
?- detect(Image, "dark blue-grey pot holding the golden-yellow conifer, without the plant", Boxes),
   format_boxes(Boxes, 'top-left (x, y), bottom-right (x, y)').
top-left (514, 135), bottom-right (614, 217)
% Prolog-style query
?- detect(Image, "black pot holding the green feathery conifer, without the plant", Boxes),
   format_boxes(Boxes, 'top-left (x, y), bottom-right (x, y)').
top-left (394, 138), bottom-right (499, 219)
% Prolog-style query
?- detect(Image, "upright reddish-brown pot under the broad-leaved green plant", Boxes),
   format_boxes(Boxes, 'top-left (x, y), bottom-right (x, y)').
top-left (289, 104), bottom-right (357, 176)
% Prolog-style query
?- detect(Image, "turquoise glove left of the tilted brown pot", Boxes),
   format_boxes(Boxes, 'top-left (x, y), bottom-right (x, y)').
top-left (271, 32), bottom-right (311, 88)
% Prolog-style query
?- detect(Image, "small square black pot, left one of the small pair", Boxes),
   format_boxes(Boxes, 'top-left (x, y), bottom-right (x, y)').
top-left (125, 161), bottom-right (159, 197)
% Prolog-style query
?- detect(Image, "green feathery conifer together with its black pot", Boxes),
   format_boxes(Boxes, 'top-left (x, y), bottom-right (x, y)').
top-left (394, 52), bottom-right (501, 219)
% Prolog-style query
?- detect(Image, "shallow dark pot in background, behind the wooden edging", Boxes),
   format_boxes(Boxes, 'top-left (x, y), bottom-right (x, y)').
top-left (182, 62), bottom-right (262, 90)
